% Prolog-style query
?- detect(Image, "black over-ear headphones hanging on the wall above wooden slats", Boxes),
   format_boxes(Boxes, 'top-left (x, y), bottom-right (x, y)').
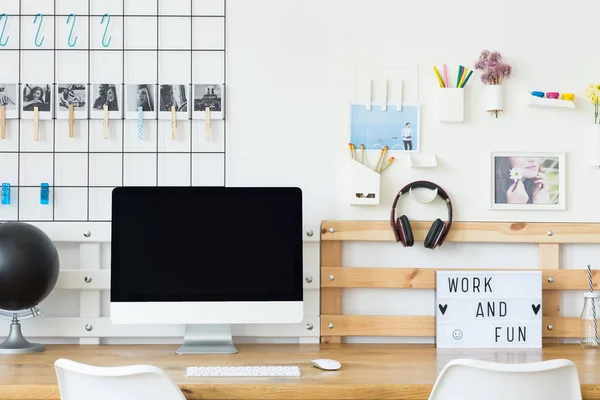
top-left (390, 181), bottom-right (452, 250)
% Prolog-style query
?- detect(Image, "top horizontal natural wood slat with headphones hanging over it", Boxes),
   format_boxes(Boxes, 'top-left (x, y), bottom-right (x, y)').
top-left (321, 221), bottom-right (600, 244)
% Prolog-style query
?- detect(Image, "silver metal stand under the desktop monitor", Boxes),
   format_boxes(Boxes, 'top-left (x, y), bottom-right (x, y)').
top-left (175, 324), bottom-right (238, 354)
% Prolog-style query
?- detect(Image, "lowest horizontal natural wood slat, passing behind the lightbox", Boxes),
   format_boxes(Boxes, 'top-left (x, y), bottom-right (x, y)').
top-left (321, 315), bottom-right (580, 338)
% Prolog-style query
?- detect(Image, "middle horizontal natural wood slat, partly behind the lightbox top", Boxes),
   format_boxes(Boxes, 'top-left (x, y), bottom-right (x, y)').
top-left (321, 268), bottom-right (600, 294)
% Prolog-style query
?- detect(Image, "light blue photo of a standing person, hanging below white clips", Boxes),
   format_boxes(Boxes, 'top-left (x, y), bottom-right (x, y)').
top-left (350, 104), bottom-right (421, 153)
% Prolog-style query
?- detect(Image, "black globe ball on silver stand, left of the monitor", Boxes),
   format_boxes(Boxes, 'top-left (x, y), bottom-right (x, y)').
top-left (0, 222), bottom-right (60, 311)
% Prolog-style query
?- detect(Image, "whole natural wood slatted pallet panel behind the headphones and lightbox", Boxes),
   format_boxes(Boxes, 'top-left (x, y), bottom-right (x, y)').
top-left (321, 221), bottom-right (600, 343)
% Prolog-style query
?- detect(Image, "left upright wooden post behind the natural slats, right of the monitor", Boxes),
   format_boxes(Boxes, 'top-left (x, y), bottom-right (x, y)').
top-left (321, 242), bottom-right (342, 343)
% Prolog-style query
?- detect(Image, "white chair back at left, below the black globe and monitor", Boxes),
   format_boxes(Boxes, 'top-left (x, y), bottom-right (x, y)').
top-left (54, 358), bottom-right (185, 400)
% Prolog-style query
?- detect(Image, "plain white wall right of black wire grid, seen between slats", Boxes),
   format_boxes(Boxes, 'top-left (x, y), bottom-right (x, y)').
top-left (227, 0), bottom-right (600, 344)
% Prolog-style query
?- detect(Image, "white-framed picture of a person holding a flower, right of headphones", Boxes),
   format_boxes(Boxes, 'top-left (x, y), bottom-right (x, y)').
top-left (491, 152), bottom-right (566, 210)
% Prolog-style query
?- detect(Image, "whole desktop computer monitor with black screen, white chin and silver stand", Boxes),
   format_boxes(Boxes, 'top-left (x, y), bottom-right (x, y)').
top-left (110, 187), bottom-right (303, 354)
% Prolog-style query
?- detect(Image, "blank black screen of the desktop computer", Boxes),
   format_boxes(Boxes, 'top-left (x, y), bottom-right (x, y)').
top-left (111, 187), bottom-right (302, 302)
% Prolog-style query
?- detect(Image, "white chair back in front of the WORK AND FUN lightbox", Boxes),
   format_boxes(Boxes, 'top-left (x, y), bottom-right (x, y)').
top-left (429, 358), bottom-right (581, 400)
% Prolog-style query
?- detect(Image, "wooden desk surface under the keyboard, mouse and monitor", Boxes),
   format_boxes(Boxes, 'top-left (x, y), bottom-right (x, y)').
top-left (0, 344), bottom-right (600, 400)
